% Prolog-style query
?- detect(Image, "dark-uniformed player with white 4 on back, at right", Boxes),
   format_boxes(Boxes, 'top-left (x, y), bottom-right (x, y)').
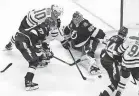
top-left (99, 27), bottom-right (128, 96)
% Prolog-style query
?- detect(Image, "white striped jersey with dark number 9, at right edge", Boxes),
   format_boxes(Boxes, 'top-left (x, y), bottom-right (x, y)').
top-left (118, 37), bottom-right (139, 68)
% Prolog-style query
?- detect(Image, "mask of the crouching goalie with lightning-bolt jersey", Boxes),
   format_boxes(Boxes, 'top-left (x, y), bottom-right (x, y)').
top-left (72, 11), bottom-right (83, 24)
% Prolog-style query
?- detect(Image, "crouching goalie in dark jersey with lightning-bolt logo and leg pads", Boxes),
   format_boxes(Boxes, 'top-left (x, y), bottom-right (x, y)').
top-left (61, 11), bottom-right (105, 74)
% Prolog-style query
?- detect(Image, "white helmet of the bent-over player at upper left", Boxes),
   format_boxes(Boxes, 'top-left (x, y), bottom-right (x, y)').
top-left (51, 5), bottom-right (63, 18)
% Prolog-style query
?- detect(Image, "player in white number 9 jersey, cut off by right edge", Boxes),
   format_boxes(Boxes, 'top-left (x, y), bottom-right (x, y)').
top-left (115, 36), bottom-right (139, 96)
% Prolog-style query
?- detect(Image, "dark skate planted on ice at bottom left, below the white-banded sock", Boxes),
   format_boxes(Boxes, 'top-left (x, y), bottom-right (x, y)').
top-left (25, 80), bottom-right (39, 91)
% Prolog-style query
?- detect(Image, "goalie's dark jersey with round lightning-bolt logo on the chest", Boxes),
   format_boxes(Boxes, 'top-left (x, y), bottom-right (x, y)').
top-left (64, 19), bottom-right (105, 47)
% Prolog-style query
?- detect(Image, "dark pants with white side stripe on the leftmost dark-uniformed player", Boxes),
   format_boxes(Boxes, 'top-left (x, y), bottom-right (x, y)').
top-left (15, 34), bottom-right (39, 68)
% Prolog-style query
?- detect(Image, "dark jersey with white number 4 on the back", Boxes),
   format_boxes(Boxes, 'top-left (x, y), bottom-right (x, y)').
top-left (106, 35), bottom-right (124, 58)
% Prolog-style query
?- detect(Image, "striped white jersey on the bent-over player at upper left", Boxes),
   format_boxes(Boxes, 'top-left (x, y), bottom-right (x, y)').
top-left (26, 8), bottom-right (51, 27)
